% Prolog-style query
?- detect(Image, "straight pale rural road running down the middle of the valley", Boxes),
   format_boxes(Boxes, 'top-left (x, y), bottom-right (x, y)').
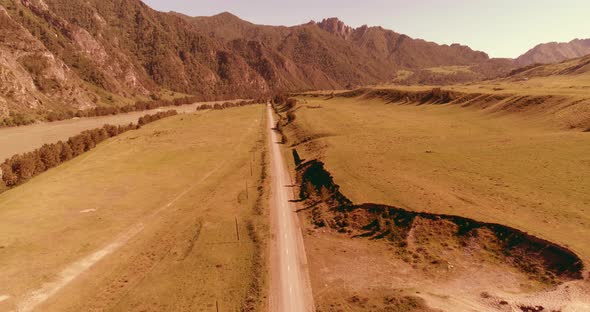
top-left (267, 105), bottom-right (315, 312)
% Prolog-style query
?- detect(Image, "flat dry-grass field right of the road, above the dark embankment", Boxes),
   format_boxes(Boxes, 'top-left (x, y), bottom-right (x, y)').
top-left (296, 94), bottom-right (590, 261)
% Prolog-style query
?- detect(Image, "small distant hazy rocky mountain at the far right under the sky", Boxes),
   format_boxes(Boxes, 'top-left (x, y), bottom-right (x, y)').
top-left (516, 39), bottom-right (590, 66)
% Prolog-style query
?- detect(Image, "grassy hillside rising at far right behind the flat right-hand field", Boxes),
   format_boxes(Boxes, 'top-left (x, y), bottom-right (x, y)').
top-left (368, 57), bottom-right (590, 131)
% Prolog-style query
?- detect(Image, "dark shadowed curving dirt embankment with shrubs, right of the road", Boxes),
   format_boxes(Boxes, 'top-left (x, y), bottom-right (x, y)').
top-left (297, 160), bottom-right (583, 284)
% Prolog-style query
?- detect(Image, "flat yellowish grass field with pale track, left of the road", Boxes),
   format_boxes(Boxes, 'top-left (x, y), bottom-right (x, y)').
top-left (0, 105), bottom-right (267, 311)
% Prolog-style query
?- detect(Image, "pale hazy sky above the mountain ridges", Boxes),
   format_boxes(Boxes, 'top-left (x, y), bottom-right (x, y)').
top-left (144, 0), bottom-right (590, 57)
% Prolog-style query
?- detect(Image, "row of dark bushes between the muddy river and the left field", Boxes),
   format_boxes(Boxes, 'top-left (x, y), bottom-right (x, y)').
top-left (0, 110), bottom-right (177, 192)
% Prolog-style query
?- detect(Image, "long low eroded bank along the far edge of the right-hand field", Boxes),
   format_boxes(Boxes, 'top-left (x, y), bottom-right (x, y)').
top-left (300, 88), bottom-right (590, 131)
